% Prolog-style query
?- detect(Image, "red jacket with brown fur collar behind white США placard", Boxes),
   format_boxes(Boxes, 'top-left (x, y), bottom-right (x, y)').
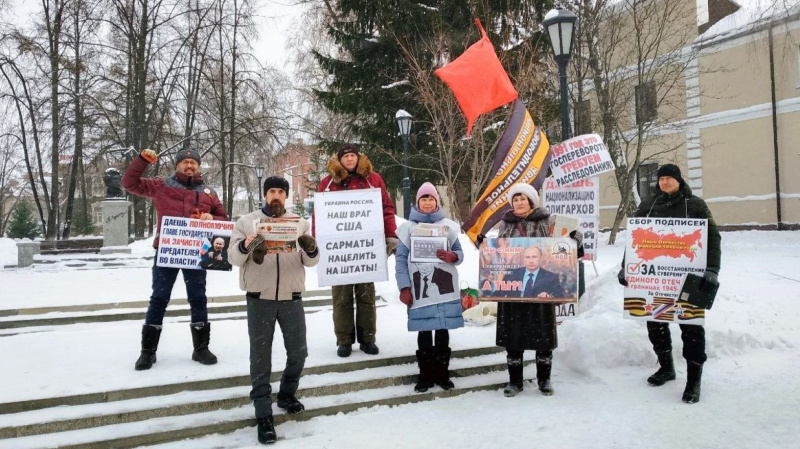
top-left (311, 153), bottom-right (397, 238)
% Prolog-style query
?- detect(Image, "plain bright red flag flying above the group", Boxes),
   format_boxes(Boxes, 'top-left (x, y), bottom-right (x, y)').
top-left (434, 19), bottom-right (519, 137)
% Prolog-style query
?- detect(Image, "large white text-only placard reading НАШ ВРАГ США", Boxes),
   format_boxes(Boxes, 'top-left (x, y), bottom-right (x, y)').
top-left (314, 189), bottom-right (389, 287)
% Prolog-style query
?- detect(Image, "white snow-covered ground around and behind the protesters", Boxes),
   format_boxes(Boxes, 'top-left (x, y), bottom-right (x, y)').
top-left (0, 231), bottom-right (800, 448)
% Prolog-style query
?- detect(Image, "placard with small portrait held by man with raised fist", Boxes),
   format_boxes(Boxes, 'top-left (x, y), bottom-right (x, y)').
top-left (156, 216), bottom-right (234, 271)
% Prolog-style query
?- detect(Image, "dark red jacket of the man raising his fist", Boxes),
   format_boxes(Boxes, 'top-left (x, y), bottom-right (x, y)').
top-left (122, 156), bottom-right (228, 248)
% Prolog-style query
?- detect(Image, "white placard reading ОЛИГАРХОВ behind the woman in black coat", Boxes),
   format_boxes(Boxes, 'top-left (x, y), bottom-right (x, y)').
top-left (542, 178), bottom-right (600, 260)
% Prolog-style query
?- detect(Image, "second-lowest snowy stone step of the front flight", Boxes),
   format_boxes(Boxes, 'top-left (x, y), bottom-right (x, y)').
top-left (0, 353), bottom-right (520, 438)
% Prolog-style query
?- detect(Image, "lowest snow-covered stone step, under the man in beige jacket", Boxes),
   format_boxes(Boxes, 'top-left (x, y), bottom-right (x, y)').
top-left (0, 364), bottom-right (507, 449)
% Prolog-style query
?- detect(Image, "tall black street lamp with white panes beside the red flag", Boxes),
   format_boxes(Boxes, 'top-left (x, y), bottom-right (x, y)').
top-left (542, 8), bottom-right (578, 140)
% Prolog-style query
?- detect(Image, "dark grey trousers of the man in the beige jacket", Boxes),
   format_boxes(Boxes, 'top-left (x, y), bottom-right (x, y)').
top-left (247, 298), bottom-right (308, 418)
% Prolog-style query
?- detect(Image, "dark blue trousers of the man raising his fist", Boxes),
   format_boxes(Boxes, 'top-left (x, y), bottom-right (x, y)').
top-left (144, 264), bottom-right (208, 326)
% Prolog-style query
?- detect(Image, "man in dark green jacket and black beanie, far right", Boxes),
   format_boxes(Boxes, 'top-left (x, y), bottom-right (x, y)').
top-left (618, 164), bottom-right (722, 404)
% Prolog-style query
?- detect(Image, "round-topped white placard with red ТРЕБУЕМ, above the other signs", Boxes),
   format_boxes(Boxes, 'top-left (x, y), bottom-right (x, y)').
top-left (550, 134), bottom-right (614, 187)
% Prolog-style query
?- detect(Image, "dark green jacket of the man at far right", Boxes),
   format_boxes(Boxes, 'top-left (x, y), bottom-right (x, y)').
top-left (634, 182), bottom-right (722, 273)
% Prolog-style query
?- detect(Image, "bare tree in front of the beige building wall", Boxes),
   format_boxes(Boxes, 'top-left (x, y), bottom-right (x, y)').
top-left (578, 0), bottom-right (709, 243)
